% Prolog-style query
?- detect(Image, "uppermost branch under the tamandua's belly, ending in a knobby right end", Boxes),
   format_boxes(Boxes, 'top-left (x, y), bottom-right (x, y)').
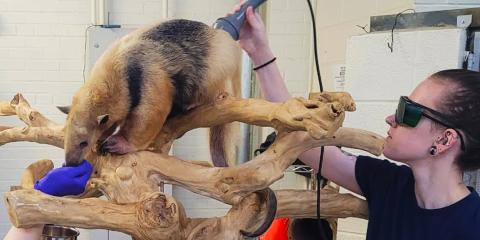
top-left (155, 93), bottom-right (355, 153)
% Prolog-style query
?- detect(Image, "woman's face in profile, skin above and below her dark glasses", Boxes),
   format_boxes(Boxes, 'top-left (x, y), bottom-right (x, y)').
top-left (383, 79), bottom-right (445, 164)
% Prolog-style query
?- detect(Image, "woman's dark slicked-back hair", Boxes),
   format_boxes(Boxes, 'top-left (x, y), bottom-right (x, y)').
top-left (430, 69), bottom-right (480, 171)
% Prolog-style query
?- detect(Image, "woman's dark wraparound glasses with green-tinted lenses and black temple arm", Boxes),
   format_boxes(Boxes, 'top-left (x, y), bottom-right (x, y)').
top-left (395, 96), bottom-right (465, 151)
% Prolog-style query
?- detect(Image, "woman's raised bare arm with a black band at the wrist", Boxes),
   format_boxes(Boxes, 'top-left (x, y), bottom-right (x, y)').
top-left (238, 5), bottom-right (361, 194)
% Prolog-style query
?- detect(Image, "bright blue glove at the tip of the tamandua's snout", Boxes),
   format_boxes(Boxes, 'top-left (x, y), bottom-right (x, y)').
top-left (34, 160), bottom-right (93, 197)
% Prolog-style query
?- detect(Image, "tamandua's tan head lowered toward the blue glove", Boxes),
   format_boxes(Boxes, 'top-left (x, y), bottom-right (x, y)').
top-left (59, 96), bottom-right (112, 166)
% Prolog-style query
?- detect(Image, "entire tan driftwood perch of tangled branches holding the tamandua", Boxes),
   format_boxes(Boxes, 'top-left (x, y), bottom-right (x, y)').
top-left (0, 93), bottom-right (383, 239)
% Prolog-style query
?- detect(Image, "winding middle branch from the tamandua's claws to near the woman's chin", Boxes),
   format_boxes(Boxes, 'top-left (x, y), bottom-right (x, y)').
top-left (88, 128), bottom-right (384, 205)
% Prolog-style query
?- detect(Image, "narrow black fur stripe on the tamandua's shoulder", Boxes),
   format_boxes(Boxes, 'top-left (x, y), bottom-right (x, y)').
top-left (127, 58), bottom-right (143, 109)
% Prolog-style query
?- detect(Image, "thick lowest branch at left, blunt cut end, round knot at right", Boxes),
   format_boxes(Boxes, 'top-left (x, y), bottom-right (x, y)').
top-left (5, 190), bottom-right (185, 239)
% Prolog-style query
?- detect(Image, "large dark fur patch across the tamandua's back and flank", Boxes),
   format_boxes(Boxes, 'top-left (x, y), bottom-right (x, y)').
top-left (142, 19), bottom-right (210, 118)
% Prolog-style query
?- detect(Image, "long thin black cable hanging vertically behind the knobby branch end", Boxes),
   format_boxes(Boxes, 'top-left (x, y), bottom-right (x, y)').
top-left (307, 0), bottom-right (327, 240)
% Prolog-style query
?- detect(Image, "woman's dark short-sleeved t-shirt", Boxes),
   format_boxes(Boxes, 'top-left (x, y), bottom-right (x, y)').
top-left (355, 156), bottom-right (480, 240)
